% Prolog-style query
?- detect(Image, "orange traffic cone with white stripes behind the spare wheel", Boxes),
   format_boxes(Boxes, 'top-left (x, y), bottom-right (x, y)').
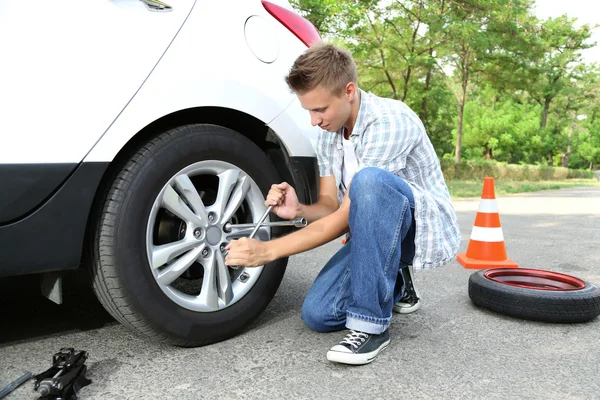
top-left (456, 178), bottom-right (519, 269)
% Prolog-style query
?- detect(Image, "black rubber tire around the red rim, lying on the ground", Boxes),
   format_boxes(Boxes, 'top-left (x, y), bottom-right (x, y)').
top-left (469, 269), bottom-right (600, 323)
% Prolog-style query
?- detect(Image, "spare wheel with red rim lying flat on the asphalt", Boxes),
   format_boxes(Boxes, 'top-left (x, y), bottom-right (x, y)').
top-left (469, 268), bottom-right (600, 323)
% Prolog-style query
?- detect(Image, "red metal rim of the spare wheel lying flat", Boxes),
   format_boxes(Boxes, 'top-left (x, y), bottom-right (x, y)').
top-left (483, 268), bottom-right (585, 291)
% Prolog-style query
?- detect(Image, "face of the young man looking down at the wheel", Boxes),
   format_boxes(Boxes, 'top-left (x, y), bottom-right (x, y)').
top-left (298, 83), bottom-right (355, 132)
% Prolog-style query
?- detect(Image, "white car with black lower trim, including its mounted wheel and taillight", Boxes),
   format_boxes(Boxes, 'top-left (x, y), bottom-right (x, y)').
top-left (0, 0), bottom-right (319, 346)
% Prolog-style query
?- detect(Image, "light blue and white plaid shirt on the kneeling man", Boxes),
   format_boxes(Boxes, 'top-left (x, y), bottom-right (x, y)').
top-left (315, 90), bottom-right (461, 271)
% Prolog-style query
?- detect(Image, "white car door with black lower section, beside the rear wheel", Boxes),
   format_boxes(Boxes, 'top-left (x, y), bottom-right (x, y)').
top-left (0, 0), bottom-right (195, 224)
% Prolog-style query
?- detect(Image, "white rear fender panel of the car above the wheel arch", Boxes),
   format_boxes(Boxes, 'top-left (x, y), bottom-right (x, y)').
top-left (85, 0), bottom-right (314, 162)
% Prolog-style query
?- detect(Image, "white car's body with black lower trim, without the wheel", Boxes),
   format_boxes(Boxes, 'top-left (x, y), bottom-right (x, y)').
top-left (0, 0), bottom-right (318, 276)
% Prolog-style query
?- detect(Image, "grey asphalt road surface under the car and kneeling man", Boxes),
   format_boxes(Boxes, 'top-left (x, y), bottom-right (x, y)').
top-left (0, 187), bottom-right (600, 399)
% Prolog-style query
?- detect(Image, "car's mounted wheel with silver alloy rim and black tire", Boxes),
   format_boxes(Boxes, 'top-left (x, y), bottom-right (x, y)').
top-left (91, 125), bottom-right (287, 346)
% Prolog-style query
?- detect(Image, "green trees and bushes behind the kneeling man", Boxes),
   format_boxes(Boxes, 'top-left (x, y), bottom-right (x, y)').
top-left (292, 0), bottom-right (600, 171)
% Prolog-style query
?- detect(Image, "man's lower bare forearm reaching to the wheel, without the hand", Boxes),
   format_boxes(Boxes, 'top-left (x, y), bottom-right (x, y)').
top-left (265, 185), bottom-right (350, 260)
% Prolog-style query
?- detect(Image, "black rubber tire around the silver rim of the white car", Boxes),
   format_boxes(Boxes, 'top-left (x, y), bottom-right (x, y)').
top-left (89, 125), bottom-right (288, 346)
